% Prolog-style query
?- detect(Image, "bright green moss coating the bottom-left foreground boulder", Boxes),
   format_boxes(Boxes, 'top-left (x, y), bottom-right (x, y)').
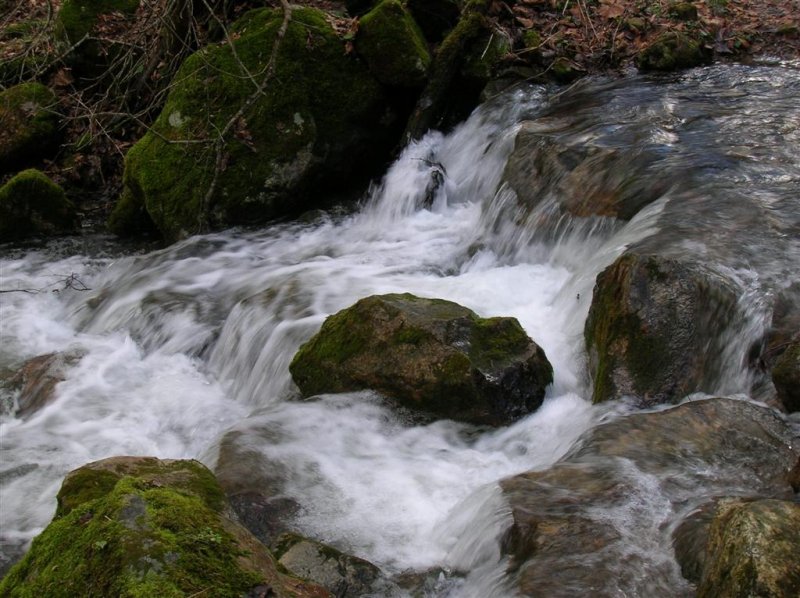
top-left (0, 460), bottom-right (263, 598)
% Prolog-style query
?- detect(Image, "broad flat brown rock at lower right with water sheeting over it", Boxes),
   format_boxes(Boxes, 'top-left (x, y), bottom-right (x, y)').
top-left (501, 398), bottom-right (800, 598)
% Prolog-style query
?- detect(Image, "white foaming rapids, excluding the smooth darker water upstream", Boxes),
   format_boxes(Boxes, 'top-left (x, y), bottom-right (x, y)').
top-left (0, 64), bottom-right (800, 596)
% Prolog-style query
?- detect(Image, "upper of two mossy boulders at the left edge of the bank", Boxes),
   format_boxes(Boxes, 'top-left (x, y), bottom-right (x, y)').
top-left (0, 83), bottom-right (59, 174)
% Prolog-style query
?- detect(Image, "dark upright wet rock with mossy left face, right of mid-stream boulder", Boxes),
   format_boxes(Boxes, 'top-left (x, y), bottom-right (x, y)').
top-left (584, 253), bottom-right (736, 407)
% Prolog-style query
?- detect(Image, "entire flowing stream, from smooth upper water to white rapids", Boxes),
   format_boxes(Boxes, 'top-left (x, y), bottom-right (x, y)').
top-left (0, 64), bottom-right (800, 596)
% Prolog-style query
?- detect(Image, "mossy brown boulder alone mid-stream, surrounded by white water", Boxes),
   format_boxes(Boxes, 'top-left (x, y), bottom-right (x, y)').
top-left (289, 294), bottom-right (553, 425)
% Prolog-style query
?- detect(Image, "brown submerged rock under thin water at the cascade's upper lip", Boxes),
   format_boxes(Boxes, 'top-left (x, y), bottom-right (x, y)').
top-left (503, 122), bottom-right (674, 226)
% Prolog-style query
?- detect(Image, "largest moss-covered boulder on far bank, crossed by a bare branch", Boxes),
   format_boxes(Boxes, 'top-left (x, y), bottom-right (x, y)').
top-left (112, 8), bottom-right (397, 240)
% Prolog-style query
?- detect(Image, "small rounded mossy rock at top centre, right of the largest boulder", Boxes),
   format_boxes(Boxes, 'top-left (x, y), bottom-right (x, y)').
top-left (355, 0), bottom-right (431, 87)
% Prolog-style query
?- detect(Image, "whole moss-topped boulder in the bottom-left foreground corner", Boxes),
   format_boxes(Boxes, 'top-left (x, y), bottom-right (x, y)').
top-left (0, 457), bottom-right (330, 598)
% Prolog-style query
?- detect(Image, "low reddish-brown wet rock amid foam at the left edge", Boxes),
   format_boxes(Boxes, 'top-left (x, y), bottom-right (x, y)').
top-left (0, 351), bottom-right (83, 419)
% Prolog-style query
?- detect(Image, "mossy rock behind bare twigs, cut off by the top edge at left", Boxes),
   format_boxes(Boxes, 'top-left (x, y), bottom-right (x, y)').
top-left (55, 0), bottom-right (139, 77)
